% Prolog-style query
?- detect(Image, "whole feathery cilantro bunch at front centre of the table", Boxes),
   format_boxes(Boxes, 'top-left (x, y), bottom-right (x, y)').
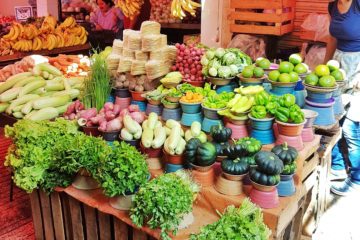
top-left (130, 171), bottom-right (199, 240)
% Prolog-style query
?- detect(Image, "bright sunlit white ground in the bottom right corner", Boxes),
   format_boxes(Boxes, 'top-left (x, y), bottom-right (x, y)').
top-left (313, 194), bottom-right (360, 240)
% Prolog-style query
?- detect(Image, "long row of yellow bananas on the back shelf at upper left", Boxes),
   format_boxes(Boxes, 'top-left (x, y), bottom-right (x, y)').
top-left (2, 16), bottom-right (88, 52)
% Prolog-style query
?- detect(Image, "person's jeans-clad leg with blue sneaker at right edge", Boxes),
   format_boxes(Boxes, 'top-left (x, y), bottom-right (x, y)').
top-left (331, 118), bottom-right (360, 196)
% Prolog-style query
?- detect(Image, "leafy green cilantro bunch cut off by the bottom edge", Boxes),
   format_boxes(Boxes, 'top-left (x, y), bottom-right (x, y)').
top-left (190, 198), bottom-right (271, 240)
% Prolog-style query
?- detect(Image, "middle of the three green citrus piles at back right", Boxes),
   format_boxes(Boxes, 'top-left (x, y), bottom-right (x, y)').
top-left (269, 54), bottom-right (309, 83)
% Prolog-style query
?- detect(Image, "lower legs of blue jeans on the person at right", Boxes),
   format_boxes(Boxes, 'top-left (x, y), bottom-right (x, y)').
top-left (331, 118), bottom-right (360, 182)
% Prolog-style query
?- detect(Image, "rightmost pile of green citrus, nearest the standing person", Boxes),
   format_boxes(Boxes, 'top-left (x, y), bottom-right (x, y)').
top-left (305, 60), bottom-right (344, 88)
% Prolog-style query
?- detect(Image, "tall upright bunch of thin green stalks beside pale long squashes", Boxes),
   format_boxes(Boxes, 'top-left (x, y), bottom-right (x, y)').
top-left (81, 54), bottom-right (111, 111)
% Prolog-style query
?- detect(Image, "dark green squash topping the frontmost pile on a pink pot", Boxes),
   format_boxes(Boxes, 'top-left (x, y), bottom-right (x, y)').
top-left (255, 151), bottom-right (284, 175)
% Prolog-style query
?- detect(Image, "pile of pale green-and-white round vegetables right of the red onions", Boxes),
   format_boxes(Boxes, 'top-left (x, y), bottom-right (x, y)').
top-left (201, 48), bottom-right (252, 78)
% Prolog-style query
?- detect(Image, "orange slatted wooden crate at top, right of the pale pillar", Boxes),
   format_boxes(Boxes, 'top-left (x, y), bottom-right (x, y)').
top-left (228, 0), bottom-right (296, 36)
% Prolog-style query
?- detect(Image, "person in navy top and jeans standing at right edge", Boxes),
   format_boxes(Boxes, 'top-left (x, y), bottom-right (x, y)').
top-left (325, 0), bottom-right (360, 196)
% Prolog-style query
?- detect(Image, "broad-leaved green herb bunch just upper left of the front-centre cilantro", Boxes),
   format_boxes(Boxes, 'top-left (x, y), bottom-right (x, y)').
top-left (96, 142), bottom-right (150, 197)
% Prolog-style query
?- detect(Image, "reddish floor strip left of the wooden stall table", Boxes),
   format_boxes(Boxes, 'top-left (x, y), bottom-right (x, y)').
top-left (0, 133), bottom-right (35, 240)
